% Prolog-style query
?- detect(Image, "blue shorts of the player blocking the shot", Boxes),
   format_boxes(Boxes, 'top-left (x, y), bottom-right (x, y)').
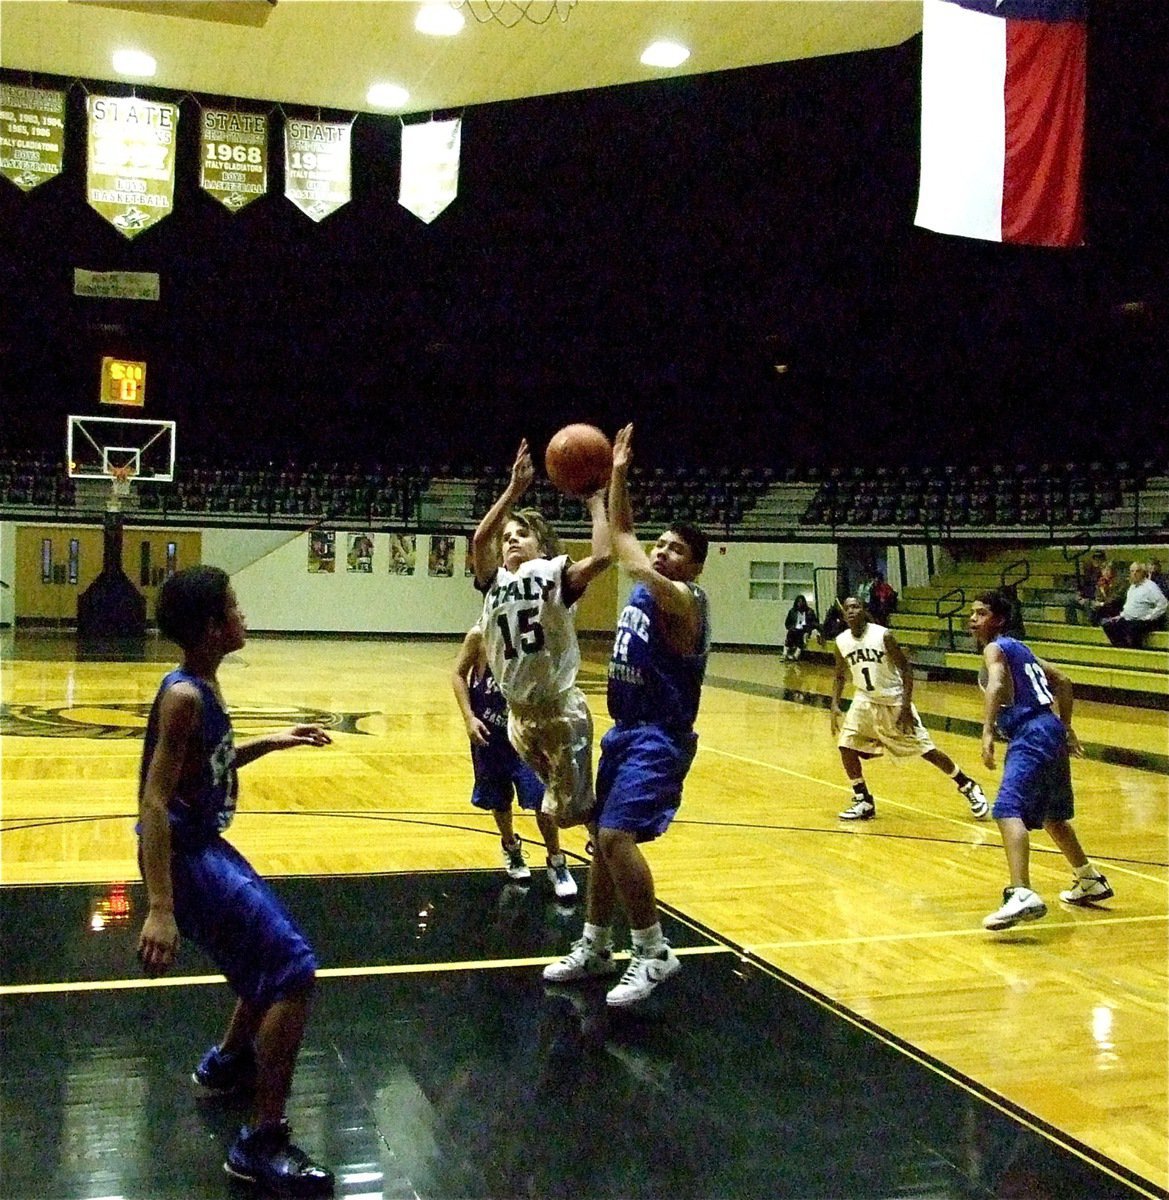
top-left (597, 725), bottom-right (699, 841)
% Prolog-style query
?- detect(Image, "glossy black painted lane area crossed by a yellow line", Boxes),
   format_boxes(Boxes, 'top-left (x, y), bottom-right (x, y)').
top-left (0, 870), bottom-right (1147, 1200)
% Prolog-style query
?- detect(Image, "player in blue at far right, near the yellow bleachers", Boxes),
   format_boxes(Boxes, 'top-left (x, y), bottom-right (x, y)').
top-left (970, 592), bottom-right (1113, 930)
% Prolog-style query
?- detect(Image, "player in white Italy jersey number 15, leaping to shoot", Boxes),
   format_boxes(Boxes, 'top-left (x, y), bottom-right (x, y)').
top-left (470, 440), bottom-right (612, 827)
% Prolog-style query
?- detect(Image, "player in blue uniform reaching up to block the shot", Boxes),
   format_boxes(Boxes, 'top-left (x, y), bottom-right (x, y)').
top-left (544, 425), bottom-right (711, 1008)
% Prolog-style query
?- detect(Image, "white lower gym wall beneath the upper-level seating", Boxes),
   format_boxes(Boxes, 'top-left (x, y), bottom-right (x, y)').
top-left (0, 522), bottom-right (837, 646)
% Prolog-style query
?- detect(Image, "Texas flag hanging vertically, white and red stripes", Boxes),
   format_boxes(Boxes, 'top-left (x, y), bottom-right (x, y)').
top-left (915, 0), bottom-right (1087, 246)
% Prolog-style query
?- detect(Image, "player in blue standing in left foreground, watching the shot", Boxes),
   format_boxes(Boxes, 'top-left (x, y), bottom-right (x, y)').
top-left (138, 566), bottom-right (332, 1196)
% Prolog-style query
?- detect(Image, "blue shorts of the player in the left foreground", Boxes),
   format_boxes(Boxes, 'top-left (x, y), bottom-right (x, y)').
top-left (170, 838), bottom-right (317, 1008)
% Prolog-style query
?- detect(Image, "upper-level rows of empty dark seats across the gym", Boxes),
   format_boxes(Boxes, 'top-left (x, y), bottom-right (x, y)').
top-left (0, 455), bottom-right (1169, 540)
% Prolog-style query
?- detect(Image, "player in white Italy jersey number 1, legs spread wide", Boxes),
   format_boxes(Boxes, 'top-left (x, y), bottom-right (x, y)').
top-left (832, 596), bottom-right (990, 821)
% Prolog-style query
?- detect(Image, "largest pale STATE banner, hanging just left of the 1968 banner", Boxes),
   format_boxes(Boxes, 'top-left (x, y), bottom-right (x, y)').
top-left (86, 96), bottom-right (179, 238)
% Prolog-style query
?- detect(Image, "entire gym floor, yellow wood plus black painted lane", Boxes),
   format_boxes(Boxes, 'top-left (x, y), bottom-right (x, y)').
top-left (0, 632), bottom-right (1169, 1200)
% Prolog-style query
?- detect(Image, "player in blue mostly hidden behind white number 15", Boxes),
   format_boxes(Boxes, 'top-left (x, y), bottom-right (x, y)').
top-left (450, 625), bottom-right (577, 900)
